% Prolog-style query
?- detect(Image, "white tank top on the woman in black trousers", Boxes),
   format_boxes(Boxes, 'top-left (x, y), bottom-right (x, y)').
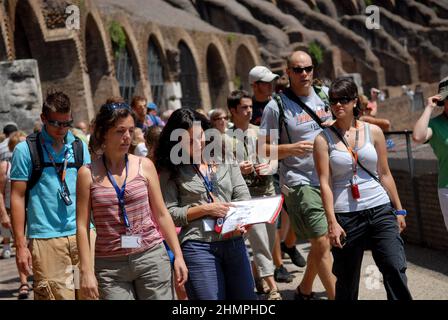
top-left (323, 123), bottom-right (390, 213)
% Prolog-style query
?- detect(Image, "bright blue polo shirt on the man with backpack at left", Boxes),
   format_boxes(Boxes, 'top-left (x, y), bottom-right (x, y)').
top-left (11, 128), bottom-right (90, 239)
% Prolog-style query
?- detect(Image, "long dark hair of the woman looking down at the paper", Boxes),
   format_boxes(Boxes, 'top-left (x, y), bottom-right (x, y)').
top-left (155, 108), bottom-right (211, 172)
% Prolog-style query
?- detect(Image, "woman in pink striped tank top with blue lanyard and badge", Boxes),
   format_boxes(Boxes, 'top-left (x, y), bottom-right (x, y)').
top-left (77, 103), bottom-right (187, 300)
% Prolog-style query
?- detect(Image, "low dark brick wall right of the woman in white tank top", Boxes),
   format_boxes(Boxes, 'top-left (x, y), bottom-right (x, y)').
top-left (392, 170), bottom-right (448, 250)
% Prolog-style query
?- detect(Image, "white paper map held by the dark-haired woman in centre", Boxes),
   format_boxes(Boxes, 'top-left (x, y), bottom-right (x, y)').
top-left (221, 195), bottom-right (283, 234)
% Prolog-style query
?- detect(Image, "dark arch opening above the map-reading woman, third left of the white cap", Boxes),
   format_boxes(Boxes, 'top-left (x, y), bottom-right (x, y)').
top-left (178, 40), bottom-right (202, 109)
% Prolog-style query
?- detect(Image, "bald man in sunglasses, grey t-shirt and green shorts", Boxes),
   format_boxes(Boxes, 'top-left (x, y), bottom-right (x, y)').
top-left (260, 51), bottom-right (336, 300)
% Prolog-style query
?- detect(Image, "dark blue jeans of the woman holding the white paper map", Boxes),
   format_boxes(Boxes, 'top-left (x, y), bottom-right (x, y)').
top-left (182, 237), bottom-right (256, 300)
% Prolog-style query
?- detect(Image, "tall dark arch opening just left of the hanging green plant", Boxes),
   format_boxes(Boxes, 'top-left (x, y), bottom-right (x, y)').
top-left (84, 14), bottom-right (112, 110)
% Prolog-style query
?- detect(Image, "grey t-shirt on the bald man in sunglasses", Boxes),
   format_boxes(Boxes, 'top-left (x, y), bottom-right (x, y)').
top-left (260, 87), bottom-right (331, 187)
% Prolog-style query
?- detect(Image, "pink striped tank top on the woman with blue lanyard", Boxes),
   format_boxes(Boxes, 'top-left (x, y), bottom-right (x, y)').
top-left (90, 159), bottom-right (162, 258)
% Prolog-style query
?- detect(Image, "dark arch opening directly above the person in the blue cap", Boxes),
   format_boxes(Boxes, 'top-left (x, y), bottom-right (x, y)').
top-left (147, 34), bottom-right (168, 110)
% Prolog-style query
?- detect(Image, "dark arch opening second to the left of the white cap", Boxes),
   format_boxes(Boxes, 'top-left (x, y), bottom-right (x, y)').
top-left (206, 43), bottom-right (229, 108)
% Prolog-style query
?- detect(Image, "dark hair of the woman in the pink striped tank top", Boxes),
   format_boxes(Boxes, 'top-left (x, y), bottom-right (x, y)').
top-left (89, 103), bottom-right (136, 154)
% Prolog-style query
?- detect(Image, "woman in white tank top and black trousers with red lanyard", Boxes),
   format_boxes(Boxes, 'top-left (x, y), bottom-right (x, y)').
top-left (314, 78), bottom-right (412, 300)
